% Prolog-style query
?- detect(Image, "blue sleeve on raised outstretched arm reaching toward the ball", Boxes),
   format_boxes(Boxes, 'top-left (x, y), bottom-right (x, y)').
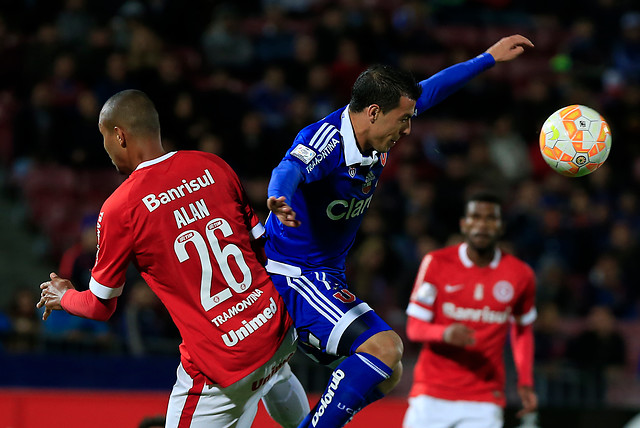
top-left (416, 52), bottom-right (496, 114)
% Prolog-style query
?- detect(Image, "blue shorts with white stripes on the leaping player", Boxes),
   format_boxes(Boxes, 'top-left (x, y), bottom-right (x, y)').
top-left (267, 266), bottom-right (391, 356)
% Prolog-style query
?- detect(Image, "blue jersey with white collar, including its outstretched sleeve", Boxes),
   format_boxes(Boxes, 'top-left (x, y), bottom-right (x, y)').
top-left (265, 53), bottom-right (495, 276)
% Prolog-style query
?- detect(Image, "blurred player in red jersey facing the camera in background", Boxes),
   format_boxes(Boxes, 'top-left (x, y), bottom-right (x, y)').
top-left (403, 193), bottom-right (538, 428)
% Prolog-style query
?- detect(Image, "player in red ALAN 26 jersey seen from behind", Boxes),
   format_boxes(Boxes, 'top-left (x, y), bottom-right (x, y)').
top-left (37, 90), bottom-right (309, 427)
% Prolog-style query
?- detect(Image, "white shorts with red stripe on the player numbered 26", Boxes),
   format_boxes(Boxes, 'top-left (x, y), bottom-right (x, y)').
top-left (165, 328), bottom-right (309, 428)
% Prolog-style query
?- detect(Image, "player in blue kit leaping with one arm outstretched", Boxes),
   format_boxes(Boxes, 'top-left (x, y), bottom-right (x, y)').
top-left (265, 35), bottom-right (533, 427)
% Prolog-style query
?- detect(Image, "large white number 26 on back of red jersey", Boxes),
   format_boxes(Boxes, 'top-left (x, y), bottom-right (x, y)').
top-left (173, 218), bottom-right (252, 311)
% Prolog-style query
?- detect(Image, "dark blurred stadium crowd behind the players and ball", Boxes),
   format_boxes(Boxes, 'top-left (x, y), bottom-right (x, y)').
top-left (0, 0), bottom-right (640, 408)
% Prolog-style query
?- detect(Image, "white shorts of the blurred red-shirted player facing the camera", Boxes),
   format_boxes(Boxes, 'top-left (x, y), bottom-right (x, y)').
top-left (402, 395), bottom-right (503, 428)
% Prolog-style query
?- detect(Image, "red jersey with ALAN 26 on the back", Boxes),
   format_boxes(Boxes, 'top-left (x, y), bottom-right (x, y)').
top-left (90, 151), bottom-right (291, 387)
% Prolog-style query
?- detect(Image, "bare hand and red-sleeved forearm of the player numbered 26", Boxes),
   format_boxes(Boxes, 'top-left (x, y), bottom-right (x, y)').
top-left (36, 272), bottom-right (117, 321)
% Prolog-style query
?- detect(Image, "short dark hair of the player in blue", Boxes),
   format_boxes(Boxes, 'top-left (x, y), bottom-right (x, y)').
top-left (349, 64), bottom-right (422, 113)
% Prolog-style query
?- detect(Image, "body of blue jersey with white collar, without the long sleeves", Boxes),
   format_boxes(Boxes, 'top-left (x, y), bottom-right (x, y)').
top-left (265, 107), bottom-right (386, 273)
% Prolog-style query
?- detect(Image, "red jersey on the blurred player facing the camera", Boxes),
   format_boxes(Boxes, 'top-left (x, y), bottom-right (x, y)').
top-left (407, 244), bottom-right (536, 406)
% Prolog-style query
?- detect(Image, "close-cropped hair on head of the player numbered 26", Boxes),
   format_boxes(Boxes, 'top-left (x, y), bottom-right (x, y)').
top-left (100, 89), bottom-right (160, 135)
